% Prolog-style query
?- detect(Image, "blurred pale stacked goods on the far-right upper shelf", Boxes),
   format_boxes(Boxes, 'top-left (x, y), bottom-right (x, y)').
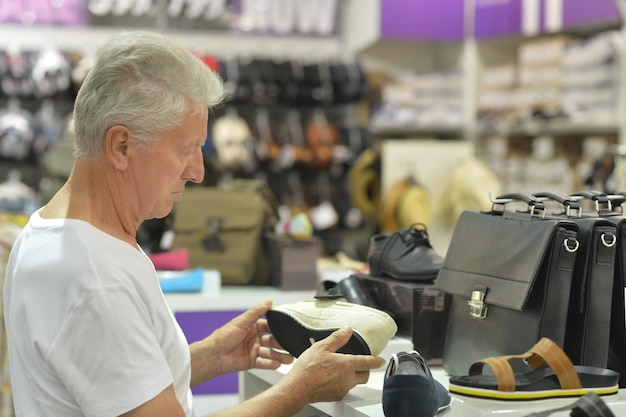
top-left (478, 31), bottom-right (621, 128)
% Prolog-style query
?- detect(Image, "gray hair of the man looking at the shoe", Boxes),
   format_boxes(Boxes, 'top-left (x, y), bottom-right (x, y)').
top-left (73, 30), bottom-right (224, 158)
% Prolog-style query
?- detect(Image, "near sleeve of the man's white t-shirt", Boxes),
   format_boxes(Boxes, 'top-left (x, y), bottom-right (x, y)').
top-left (47, 285), bottom-right (173, 417)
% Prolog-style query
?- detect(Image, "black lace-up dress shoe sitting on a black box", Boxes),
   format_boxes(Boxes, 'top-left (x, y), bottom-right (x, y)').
top-left (367, 223), bottom-right (443, 282)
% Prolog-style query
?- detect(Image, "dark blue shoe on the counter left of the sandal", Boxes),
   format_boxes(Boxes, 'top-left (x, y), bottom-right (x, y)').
top-left (383, 350), bottom-right (450, 417)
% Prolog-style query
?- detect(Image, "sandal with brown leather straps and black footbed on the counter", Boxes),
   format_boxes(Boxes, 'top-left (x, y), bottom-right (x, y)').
top-left (450, 337), bottom-right (619, 401)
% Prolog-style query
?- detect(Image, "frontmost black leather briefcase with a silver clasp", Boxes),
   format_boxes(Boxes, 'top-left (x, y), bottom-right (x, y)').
top-left (434, 194), bottom-right (580, 375)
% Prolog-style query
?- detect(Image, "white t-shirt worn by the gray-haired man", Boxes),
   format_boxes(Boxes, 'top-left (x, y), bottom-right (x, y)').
top-left (4, 213), bottom-right (192, 417)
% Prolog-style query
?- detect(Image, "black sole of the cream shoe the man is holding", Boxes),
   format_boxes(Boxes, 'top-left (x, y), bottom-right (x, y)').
top-left (266, 310), bottom-right (371, 358)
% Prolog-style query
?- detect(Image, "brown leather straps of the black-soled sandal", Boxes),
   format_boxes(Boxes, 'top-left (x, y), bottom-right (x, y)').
top-left (469, 337), bottom-right (582, 392)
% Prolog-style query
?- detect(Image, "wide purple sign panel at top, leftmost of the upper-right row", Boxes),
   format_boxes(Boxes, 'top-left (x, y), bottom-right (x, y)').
top-left (381, 0), bottom-right (464, 40)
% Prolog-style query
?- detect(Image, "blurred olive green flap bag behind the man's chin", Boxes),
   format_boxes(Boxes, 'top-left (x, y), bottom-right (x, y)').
top-left (172, 179), bottom-right (278, 285)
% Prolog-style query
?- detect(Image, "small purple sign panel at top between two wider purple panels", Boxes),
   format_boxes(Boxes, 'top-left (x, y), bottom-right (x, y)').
top-left (474, 0), bottom-right (522, 38)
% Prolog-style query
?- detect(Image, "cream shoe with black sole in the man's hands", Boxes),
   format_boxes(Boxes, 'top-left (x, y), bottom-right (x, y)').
top-left (266, 297), bottom-right (398, 357)
